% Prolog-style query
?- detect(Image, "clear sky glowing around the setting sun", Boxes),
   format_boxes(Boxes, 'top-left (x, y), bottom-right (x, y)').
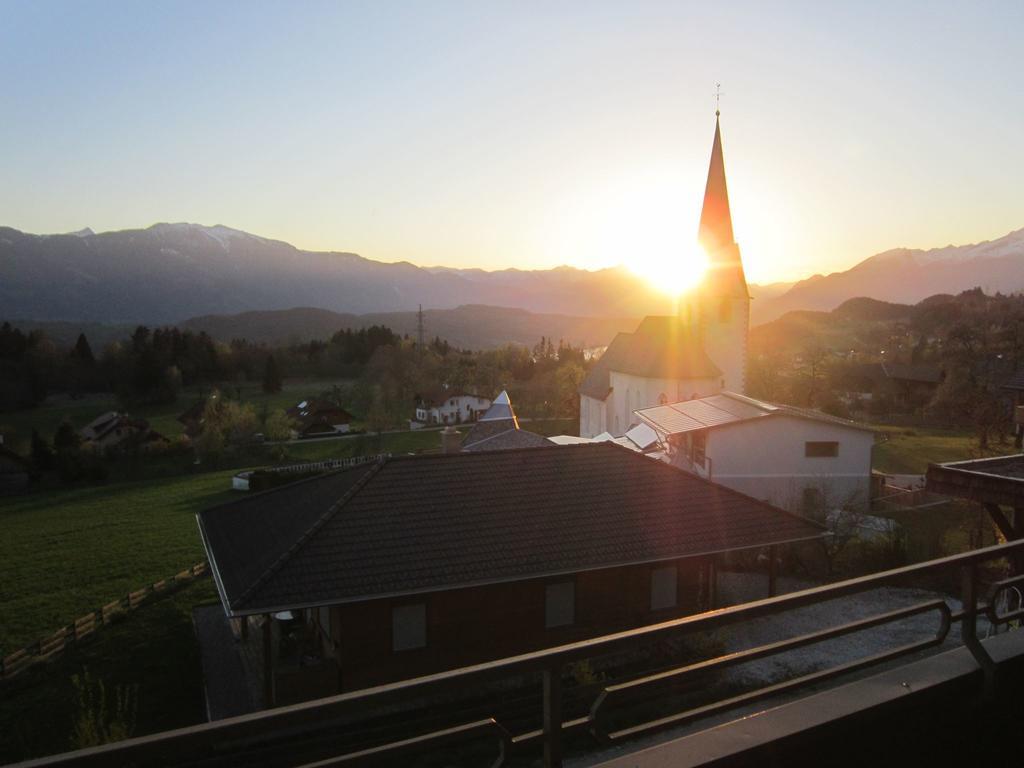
top-left (0, 0), bottom-right (1024, 283)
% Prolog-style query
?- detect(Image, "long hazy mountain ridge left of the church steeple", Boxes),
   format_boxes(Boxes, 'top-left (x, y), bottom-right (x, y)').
top-left (0, 224), bottom-right (779, 325)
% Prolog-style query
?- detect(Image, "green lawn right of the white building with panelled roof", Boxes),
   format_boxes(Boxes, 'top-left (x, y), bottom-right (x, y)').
top-left (874, 425), bottom-right (1012, 474)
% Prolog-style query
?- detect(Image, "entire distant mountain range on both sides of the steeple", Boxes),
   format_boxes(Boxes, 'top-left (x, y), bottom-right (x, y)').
top-left (0, 223), bottom-right (1024, 331)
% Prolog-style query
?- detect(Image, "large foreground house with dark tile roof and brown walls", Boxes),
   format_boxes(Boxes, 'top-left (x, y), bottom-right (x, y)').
top-left (198, 443), bottom-right (823, 703)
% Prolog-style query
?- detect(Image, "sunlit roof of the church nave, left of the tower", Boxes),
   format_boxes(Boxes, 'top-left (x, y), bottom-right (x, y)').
top-left (580, 315), bottom-right (722, 400)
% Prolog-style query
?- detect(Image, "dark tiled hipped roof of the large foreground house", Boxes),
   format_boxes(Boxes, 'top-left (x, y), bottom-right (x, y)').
top-left (198, 444), bottom-right (823, 614)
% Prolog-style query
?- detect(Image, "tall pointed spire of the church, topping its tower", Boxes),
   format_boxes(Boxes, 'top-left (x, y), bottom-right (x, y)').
top-left (697, 110), bottom-right (749, 298)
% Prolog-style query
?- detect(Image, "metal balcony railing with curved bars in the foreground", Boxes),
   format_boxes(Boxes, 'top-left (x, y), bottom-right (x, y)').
top-left (16, 541), bottom-right (1024, 768)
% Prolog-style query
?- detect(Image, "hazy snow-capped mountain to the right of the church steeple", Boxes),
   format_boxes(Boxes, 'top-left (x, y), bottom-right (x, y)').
top-left (752, 229), bottom-right (1024, 324)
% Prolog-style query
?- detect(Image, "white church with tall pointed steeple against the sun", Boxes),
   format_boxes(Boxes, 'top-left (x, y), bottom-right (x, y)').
top-left (580, 111), bottom-right (751, 437)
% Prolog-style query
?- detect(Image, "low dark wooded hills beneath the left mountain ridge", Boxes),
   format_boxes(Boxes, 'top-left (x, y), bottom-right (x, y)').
top-left (178, 304), bottom-right (638, 349)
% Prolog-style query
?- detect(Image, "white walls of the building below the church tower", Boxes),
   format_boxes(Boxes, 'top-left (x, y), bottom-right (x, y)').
top-left (688, 416), bottom-right (874, 514)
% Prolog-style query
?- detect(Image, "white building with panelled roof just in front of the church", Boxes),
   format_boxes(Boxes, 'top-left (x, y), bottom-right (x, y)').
top-left (636, 392), bottom-right (874, 518)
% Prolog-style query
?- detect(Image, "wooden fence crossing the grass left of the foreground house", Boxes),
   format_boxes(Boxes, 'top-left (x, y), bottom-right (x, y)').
top-left (0, 562), bottom-right (207, 680)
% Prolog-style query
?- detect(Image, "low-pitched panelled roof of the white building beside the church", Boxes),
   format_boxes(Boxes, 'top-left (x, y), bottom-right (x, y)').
top-left (635, 392), bottom-right (874, 435)
